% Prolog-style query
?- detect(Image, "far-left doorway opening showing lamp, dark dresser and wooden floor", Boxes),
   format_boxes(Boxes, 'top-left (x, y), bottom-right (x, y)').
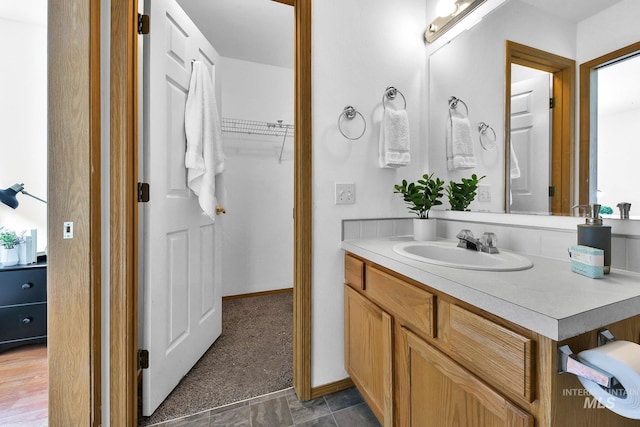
top-left (0, 0), bottom-right (49, 425)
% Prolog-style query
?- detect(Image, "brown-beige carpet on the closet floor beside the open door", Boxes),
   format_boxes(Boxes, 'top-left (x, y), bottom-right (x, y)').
top-left (138, 292), bottom-right (293, 426)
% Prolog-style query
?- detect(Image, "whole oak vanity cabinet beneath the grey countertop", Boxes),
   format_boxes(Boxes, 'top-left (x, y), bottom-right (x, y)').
top-left (344, 253), bottom-right (640, 427)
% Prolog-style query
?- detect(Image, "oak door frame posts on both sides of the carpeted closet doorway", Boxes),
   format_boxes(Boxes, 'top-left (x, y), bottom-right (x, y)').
top-left (110, 0), bottom-right (312, 425)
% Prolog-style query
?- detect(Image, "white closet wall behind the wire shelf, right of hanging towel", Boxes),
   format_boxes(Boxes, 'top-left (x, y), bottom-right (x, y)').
top-left (218, 56), bottom-right (293, 296)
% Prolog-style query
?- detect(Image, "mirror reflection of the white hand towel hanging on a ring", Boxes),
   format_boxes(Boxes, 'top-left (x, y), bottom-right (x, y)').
top-left (445, 108), bottom-right (476, 170)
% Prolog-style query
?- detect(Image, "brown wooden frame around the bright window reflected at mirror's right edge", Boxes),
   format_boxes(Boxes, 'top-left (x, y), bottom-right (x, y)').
top-left (578, 42), bottom-right (640, 205)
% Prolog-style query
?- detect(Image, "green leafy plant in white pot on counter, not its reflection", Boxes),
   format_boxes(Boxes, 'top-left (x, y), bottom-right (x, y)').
top-left (394, 174), bottom-right (444, 240)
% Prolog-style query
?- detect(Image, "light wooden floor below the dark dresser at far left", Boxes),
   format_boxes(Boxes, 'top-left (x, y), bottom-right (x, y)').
top-left (0, 344), bottom-right (49, 427)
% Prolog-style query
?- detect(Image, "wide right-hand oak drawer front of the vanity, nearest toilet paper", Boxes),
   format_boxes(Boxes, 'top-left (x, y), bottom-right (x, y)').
top-left (449, 305), bottom-right (535, 402)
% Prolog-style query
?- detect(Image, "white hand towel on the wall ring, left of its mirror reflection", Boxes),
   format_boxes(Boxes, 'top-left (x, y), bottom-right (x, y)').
top-left (378, 107), bottom-right (411, 168)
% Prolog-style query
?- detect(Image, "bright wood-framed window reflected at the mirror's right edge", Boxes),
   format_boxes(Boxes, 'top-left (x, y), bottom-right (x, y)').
top-left (579, 42), bottom-right (640, 219)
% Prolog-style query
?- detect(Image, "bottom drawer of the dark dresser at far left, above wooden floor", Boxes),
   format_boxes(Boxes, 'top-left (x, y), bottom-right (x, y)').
top-left (0, 303), bottom-right (47, 341)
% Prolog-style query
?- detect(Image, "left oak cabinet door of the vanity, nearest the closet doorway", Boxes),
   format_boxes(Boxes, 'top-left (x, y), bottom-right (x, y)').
top-left (344, 285), bottom-right (393, 427)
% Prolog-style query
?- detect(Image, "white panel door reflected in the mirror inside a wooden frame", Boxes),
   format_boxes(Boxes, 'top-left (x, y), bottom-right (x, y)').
top-left (511, 74), bottom-right (551, 214)
